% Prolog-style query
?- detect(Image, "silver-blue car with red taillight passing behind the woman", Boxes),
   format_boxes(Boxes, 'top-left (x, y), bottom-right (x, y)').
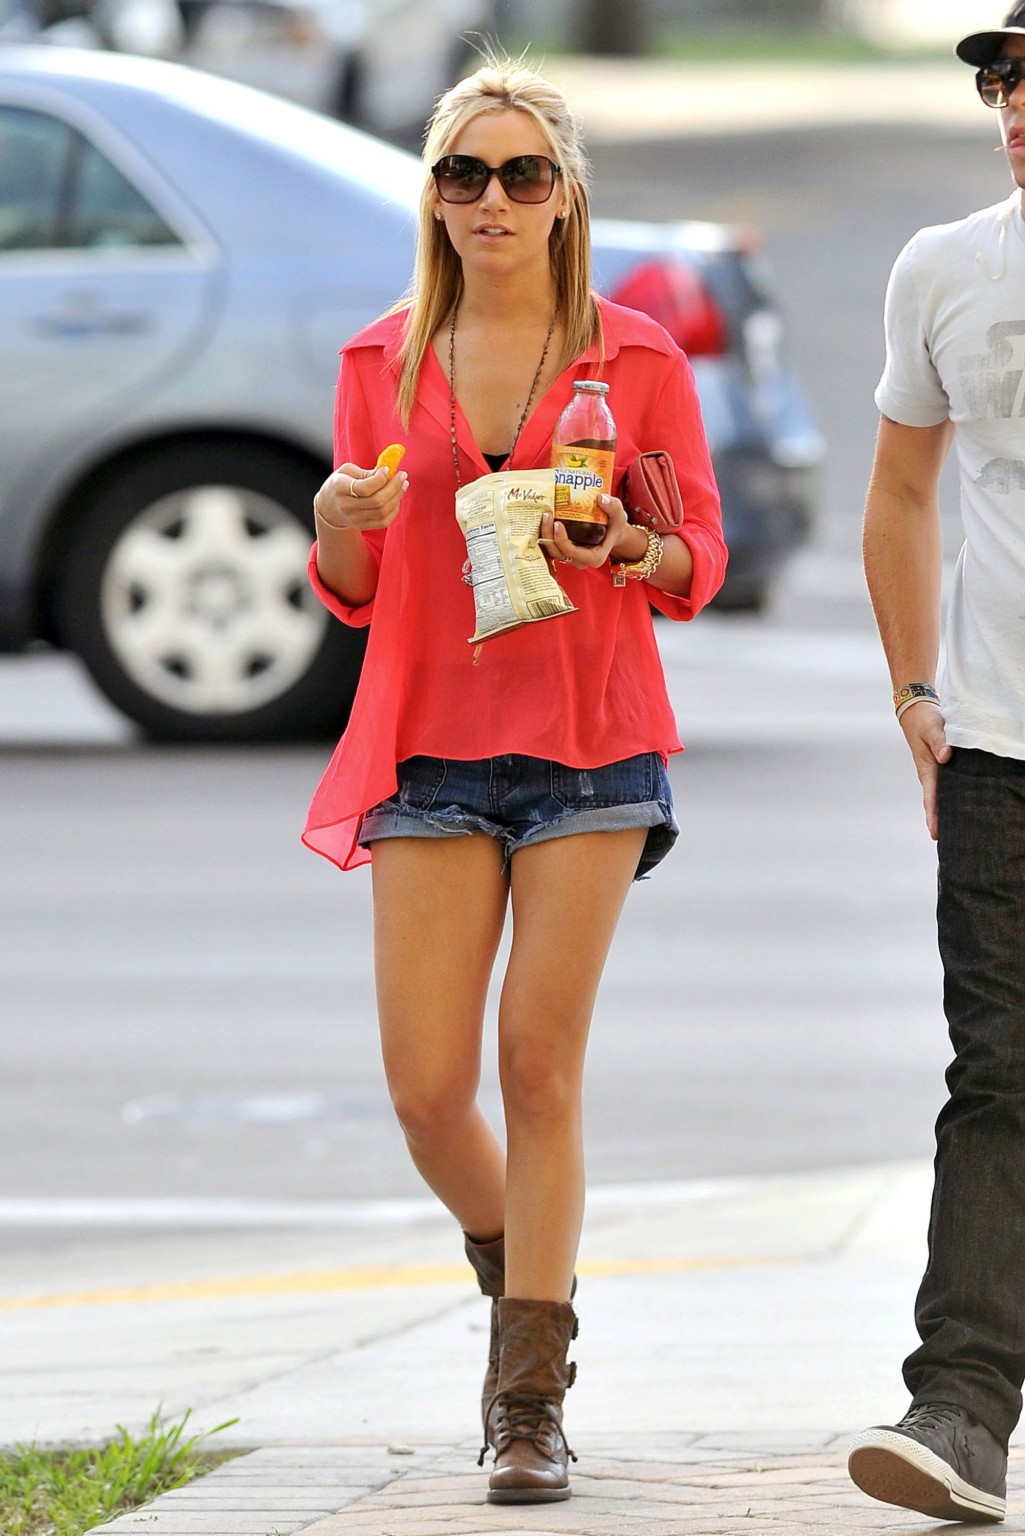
top-left (0, 48), bottom-right (822, 740)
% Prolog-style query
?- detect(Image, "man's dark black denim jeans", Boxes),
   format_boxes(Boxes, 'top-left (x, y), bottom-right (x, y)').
top-left (904, 748), bottom-right (1025, 1444)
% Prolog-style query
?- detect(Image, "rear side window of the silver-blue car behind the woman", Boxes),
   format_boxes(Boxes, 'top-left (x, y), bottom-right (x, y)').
top-left (0, 108), bottom-right (181, 250)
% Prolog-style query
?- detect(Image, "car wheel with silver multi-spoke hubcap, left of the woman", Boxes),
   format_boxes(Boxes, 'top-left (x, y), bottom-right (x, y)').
top-left (57, 444), bottom-right (366, 742)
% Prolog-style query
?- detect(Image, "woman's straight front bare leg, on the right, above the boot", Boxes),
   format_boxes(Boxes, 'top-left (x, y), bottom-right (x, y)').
top-left (498, 828), bottom-right (647, 1301)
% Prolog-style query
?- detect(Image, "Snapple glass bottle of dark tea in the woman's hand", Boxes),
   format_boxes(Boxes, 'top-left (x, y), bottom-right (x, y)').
top-left (552, 379), bottom-right (616, 548)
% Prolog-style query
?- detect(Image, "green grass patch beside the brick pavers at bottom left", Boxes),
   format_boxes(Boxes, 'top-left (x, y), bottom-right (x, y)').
top-left (0, 1413), bottom-right (238, 1536)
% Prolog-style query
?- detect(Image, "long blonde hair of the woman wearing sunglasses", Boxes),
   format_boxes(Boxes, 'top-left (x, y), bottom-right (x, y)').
top-left (390, 58), bottom-right (604, 425)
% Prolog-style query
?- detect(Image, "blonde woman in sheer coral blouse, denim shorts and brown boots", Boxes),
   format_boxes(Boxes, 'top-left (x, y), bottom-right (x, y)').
top-left (304, 61), bottom-right (725, 1504)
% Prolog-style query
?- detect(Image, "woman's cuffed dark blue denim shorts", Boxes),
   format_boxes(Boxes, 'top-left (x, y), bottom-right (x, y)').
top-left (360, 753), bottom-right (679, 880)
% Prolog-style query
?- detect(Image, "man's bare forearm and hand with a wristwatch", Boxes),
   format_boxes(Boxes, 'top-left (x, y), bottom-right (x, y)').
top-left (864, 416), bottom-right (953, 837)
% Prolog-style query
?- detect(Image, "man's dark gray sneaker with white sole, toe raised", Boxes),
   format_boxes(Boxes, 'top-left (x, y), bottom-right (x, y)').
top-left (847, 1402), bottom-right (1007, 1521)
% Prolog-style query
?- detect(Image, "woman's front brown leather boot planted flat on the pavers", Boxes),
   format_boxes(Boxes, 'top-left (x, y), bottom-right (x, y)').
top-left (481, 1296), bottom-right (576, 1504)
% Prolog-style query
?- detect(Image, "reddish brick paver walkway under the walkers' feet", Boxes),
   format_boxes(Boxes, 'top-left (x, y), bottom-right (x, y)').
top-left (86, 1435), bottom-right (1025, 1536)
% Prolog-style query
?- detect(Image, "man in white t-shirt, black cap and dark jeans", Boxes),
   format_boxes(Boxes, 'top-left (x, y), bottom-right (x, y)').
top-left (850, 9), bottom-right (1025, 1521)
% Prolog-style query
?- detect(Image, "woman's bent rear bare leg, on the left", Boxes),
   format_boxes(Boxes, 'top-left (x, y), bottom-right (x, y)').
top-left (372, 833), bottom-right (509, 1241)
